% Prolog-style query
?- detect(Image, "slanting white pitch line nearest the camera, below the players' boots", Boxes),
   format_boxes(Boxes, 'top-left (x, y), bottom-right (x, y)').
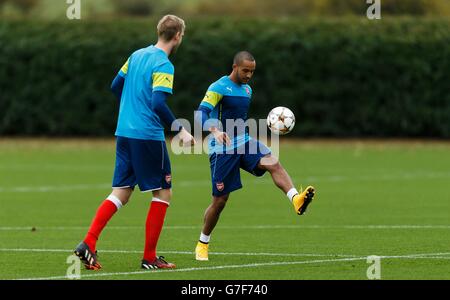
top-left (16, 254), bottom-right (446, 280)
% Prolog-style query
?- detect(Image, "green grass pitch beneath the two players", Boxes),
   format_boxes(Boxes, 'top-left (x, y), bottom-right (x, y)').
top-left (0, 140), bottom-right (450, 280)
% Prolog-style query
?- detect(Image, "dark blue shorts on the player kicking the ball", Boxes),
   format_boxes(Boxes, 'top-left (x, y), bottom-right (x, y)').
top-left (209, 139), bottom-right (270, 196)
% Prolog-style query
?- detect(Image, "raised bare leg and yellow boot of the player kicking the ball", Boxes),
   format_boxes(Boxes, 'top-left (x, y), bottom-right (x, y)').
top-left (258, 155), bottom-right (315, 215)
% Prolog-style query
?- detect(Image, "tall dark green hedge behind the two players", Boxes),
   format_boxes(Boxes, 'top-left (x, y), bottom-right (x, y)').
top-left (0, 18), bottom-right (450, 138)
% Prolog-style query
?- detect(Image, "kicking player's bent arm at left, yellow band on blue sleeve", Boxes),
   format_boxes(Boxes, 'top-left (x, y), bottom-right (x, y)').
top-left (195, 87), bottom-right (231, 145)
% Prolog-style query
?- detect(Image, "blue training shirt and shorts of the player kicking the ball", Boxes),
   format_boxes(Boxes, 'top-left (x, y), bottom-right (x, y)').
top-left (196, 76), bottom-right (271, 196)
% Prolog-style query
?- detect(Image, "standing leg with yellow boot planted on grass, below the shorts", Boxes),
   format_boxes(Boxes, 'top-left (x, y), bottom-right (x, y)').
top-left (195, 194), bottom-right (230, 261)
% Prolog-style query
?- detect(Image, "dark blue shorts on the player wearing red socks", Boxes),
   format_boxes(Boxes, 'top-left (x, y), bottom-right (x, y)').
top-left (113, 136), bottom-right (172, 192)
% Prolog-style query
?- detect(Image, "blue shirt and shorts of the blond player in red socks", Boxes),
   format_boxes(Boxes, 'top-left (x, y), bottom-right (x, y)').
top-left (111, 45), bottom-right (181, 191)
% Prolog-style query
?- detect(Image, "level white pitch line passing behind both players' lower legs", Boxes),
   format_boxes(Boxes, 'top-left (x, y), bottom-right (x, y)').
top-left (0, 225), bottom-right (450, 231)
